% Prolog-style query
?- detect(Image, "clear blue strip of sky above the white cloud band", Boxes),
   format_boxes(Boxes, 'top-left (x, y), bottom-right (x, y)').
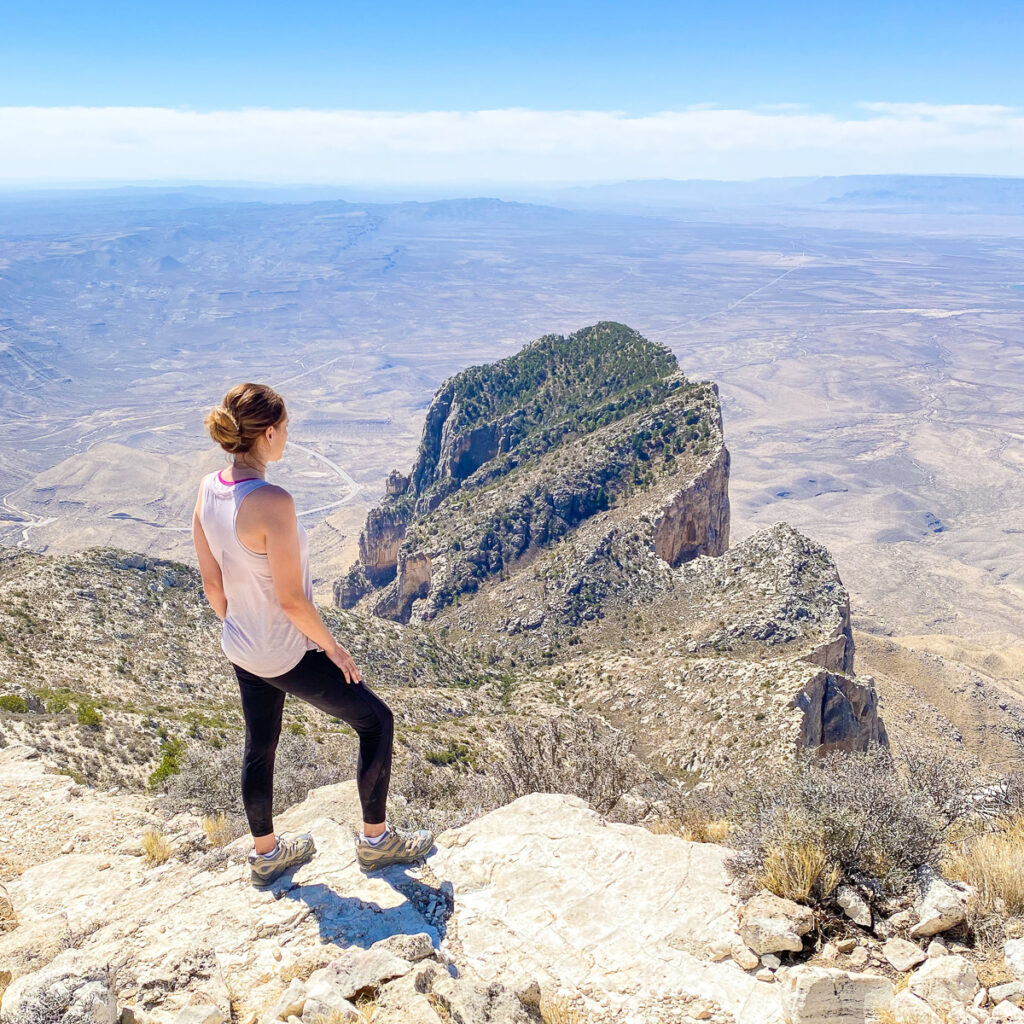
top-left (0, 0), bottom-right (1024, 114)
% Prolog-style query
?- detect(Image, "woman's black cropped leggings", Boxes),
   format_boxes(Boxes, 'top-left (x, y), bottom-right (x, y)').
top-left (230, 650), bottom-right (394, 836)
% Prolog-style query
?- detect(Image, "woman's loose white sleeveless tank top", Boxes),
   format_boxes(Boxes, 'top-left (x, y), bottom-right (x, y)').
top-left (199, 472), bottom-right (318, 677)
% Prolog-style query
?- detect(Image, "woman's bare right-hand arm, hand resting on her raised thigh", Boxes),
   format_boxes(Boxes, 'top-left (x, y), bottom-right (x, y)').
top-left (264, 488), bottom-right (362, 683)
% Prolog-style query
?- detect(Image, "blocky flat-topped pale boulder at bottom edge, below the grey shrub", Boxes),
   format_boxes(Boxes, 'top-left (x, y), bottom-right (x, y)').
top-left (778, 964), bottom-right (893, 1024)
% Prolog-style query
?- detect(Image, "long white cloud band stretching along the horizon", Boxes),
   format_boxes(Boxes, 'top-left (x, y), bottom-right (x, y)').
top-left (0, 102), bottom-right (1024, 184)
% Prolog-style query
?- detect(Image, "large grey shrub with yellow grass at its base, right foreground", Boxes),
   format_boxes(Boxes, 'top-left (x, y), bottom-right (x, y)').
top-left (731, 748), bottom-right (971, 900)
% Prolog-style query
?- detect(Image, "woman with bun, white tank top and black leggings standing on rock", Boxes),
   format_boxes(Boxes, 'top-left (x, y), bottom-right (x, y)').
top-left (193, 383), bottom-right (433, 888)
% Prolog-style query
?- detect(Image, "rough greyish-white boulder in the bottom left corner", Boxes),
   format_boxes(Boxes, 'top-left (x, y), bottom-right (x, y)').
top-left (0, 949), bottom-right (118, 1024)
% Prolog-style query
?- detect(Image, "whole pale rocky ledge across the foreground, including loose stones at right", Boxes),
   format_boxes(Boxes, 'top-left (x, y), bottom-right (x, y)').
top-left (0, 746), bottom-right (1024, 1024)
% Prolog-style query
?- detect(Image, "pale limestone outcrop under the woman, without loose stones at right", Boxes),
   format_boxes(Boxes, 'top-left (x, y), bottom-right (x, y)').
top-left (0, 751), bottom-right (806, 1024)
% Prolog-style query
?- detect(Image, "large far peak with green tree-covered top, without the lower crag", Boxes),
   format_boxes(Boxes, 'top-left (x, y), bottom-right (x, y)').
top-left (335, 324), bottom-right (728, 622)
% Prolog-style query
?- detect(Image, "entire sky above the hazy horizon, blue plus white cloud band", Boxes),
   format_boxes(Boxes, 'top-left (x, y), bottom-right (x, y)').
top-left (0, 0), bottom-right (1024, 185)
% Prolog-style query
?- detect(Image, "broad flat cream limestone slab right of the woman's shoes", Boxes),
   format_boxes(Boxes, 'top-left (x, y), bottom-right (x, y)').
top-left (428, 794), bottom-right (782, 1024)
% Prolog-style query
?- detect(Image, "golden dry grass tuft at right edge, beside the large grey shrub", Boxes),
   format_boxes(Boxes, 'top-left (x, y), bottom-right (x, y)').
top-left (942, 814), bottom-right (1024, 916)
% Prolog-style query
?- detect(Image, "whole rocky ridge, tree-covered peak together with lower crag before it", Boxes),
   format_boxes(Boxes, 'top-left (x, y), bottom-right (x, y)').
top-left (325, 324), bottom-right (886, 773)
